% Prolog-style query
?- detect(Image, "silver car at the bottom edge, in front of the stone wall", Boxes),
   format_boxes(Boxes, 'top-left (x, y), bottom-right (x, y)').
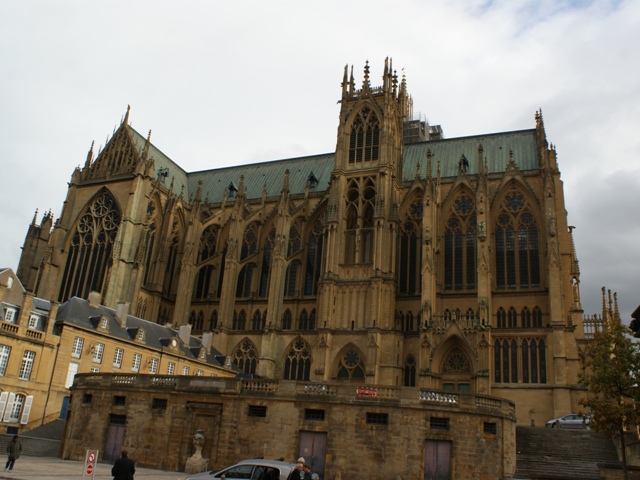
top-left (185, 458), bottom-right (296, 480)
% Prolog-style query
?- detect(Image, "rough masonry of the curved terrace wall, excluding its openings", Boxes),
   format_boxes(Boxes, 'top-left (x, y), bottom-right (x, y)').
top-left (63, 376), bottom-right (515, 480)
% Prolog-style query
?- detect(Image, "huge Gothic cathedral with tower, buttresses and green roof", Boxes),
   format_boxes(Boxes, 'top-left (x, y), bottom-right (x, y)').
top-left (17, 60), bottom-right (584, 425)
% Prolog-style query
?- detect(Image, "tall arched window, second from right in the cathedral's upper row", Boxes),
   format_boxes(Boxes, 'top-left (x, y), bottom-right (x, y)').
top-left (444, 193), bottom-right (476, 290)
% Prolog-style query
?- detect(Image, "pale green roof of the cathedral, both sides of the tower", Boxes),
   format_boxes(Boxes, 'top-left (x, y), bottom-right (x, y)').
top-left (128, 126), bottom-right (540, 202)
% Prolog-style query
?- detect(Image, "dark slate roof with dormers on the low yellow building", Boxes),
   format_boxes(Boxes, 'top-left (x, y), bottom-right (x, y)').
top-left (56, 297), bottom-right (235, 373)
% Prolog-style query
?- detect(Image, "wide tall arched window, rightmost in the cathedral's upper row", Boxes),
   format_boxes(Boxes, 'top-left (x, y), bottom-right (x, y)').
top-left (496, 190), bottom-right (540, 288)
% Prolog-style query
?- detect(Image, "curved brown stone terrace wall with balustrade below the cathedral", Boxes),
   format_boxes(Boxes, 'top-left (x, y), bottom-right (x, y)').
top-left (63, 374), bottom-right (516, 479)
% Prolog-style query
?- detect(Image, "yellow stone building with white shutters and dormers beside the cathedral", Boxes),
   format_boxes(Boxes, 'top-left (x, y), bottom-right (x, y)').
top-left (0, 268), bottom-right (238, 433)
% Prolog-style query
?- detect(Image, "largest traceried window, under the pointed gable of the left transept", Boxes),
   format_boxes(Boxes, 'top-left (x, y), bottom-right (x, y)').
top-left (58, 193), bottom-right (120, 302)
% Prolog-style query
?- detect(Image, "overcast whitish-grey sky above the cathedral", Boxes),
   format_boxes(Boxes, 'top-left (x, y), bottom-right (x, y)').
top-left (0, 0), bottom-right (640, 321)
